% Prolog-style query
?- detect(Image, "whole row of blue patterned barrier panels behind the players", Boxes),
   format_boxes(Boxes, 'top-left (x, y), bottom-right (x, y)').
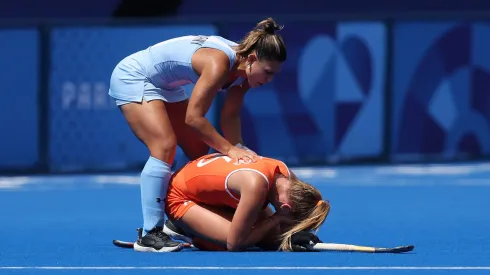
top-left (0, 18), bottom-right (490, 172)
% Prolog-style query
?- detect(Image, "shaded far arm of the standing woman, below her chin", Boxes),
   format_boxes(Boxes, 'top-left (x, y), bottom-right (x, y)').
top-left (221, 81), bottom-right (249, 145)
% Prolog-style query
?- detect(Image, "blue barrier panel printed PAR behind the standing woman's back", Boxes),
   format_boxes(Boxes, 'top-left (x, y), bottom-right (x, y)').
top-left (49, 25), bottom-right (216, 171)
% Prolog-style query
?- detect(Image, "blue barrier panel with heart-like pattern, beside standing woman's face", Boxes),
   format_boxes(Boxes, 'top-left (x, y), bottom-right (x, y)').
top-left (226, 22), bottom-right (386, 164)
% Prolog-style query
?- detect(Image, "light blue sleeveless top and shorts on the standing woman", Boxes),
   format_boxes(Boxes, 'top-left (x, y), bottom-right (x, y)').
top-left (109, 35), bottom-right (244, 105)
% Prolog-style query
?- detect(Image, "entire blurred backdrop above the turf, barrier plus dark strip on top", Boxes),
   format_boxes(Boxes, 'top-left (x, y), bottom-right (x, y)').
top-left (0, 0), bottom-right (490, 175)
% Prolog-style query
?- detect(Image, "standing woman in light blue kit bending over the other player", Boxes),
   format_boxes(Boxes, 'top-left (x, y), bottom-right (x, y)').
top-left (109, 18), bottom-right (286, 252)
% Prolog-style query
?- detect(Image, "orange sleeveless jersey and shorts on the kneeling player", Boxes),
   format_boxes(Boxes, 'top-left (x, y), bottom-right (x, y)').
top-left (167, 154), bottom-right (290, 218)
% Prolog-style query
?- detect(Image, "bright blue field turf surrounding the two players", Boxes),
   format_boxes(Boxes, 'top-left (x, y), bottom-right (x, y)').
top-left (0, 163), bottom-right (490, 275)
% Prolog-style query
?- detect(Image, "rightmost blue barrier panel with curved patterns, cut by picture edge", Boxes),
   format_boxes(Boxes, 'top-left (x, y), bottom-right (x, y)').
top-left (391, 22), bottom-right (490, 161)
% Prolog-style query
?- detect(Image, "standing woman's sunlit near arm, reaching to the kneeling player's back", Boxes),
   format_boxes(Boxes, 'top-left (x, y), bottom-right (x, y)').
top-left (185, 52), bottom-right (232, 154)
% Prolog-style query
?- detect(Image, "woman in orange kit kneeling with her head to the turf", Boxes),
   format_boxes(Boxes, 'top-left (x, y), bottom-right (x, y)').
top-left (166, 154), bottom-right (330, 251)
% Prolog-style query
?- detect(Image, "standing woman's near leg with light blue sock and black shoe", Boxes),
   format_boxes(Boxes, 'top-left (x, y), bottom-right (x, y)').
top-left (121, 100), bottom-right (180, 251)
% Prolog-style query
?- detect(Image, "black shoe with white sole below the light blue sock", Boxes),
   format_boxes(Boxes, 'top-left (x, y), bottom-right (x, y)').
top-left (134, 227), bottom-right (184, 252)
